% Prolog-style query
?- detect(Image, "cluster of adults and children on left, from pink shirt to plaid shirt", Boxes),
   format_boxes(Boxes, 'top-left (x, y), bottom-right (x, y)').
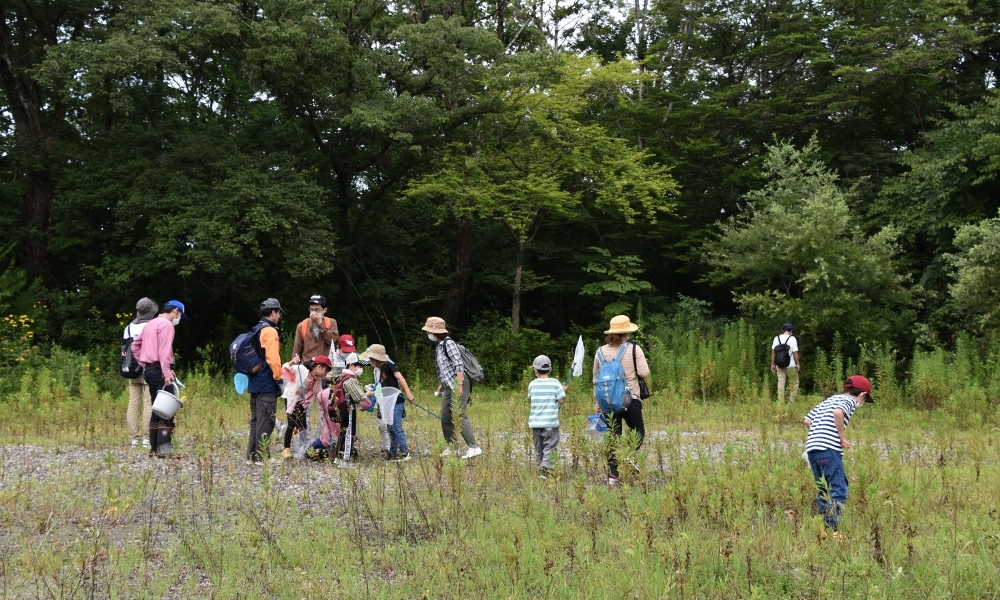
top-left (123, 295), bottom-right (483, 463)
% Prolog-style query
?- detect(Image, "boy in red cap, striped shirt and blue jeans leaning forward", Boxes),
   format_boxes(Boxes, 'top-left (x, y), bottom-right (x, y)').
top-left (805, 375), bottom-right (874, 537)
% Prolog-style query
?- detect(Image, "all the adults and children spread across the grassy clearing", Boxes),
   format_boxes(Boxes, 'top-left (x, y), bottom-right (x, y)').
top-left (123, 295), bottom-right (872, 535)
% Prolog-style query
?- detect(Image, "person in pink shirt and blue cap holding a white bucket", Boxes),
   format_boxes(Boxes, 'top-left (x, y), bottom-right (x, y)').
top-left (132, 300), bottom-right (187, 458)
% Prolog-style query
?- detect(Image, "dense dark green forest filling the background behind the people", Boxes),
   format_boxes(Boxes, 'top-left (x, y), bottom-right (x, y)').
top-left (0, 0), bottom-right (1000, 390)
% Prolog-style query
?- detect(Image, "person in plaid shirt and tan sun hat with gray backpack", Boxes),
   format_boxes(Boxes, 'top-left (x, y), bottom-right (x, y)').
top-left (421, 317), bottom-right (483, 459)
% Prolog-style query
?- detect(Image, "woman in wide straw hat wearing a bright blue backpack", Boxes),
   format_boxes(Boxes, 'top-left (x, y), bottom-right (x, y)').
top-left (593, 315), bottom-right (649, 485)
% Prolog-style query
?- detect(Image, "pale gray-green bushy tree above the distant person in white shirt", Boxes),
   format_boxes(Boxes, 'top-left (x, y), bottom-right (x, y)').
top-left (705, 138), bottom-right (914, 343)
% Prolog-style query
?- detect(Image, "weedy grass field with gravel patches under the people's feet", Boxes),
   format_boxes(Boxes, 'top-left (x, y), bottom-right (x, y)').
top-left (0, 374), bottom-right (1000, 598)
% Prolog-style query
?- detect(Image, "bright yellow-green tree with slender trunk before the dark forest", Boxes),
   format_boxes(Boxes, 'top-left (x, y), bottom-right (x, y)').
top-left (407, 55), bottom-right (678, 334)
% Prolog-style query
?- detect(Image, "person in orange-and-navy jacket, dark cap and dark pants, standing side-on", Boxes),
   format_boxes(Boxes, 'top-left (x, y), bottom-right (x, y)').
top-left (247, 298), bottom-right (285, 464)
